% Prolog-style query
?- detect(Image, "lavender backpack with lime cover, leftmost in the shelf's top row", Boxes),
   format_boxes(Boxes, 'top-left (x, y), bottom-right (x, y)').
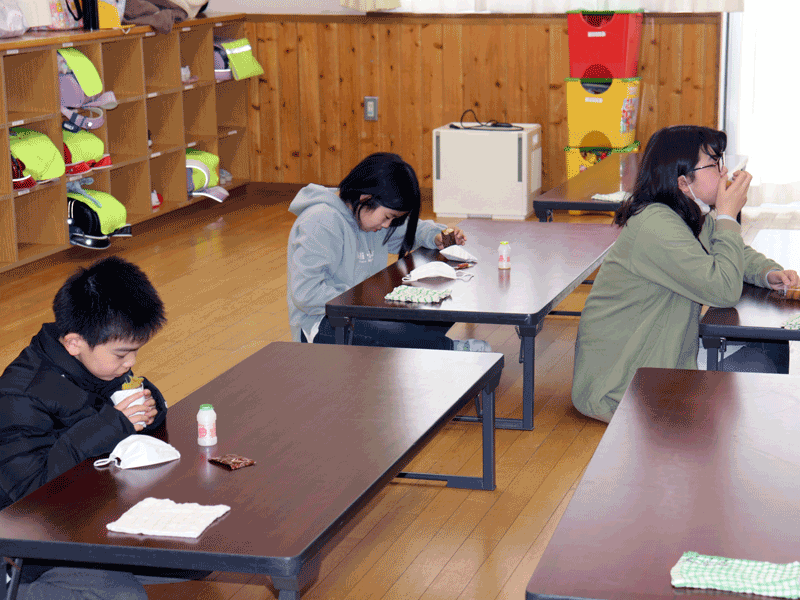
top-left (58, 48), bottom-right (117, 132)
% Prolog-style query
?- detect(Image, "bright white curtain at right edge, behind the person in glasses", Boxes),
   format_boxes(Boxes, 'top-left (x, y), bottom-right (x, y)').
top-left (728, 0), bottom-right (800, 209)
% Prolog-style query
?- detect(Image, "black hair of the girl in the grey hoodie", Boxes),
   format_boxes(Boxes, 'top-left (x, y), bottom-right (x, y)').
top-left (339, 152), bottom-right (420, 258)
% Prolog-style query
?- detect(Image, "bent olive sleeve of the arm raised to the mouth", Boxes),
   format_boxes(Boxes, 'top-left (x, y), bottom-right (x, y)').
top-left (629, 209), bottom-right (745, 307)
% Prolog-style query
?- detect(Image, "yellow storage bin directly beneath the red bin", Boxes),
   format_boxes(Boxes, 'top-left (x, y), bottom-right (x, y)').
top-left (566, 77), bottom-right (642, 148)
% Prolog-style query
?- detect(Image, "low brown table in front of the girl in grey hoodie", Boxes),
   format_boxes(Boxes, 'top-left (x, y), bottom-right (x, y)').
top-left (326, 219), bottom-right (619, 430)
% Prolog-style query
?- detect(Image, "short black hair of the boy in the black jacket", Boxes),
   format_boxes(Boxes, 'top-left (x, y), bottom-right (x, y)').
top-left (53, 256), bottom-right (166, 348)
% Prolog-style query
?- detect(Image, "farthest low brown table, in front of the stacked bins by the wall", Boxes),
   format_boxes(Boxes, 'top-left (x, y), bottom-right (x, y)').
top-left (533, 152), bottom-right (642, 223)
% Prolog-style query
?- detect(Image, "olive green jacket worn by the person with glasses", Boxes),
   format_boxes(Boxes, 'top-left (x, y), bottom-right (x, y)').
top-left (572, 204), bottom-right (782, 420)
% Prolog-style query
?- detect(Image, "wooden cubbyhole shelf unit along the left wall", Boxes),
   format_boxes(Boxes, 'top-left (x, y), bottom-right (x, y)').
top-left (0, 14), bottom-right (251, 271)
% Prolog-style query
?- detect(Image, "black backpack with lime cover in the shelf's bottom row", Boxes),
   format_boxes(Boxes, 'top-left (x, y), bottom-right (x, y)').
top-left (67, 177), bottom-right (132, 250)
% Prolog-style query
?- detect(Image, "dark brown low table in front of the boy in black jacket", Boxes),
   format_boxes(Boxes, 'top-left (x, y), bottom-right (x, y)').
top-left (0, 342), bottom-right (503, 600)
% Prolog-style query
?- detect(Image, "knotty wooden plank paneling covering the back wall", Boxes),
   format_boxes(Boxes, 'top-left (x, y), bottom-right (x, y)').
top-left (251, 14), bottom-right (721, 189)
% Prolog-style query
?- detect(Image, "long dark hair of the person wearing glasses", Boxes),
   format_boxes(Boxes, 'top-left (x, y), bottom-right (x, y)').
top-left (614, 125), bottom-right (728, 237)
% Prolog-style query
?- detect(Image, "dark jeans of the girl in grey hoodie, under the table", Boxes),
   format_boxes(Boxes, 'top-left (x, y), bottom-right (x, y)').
top-left (300, 317), bottom-right (453, 350)
